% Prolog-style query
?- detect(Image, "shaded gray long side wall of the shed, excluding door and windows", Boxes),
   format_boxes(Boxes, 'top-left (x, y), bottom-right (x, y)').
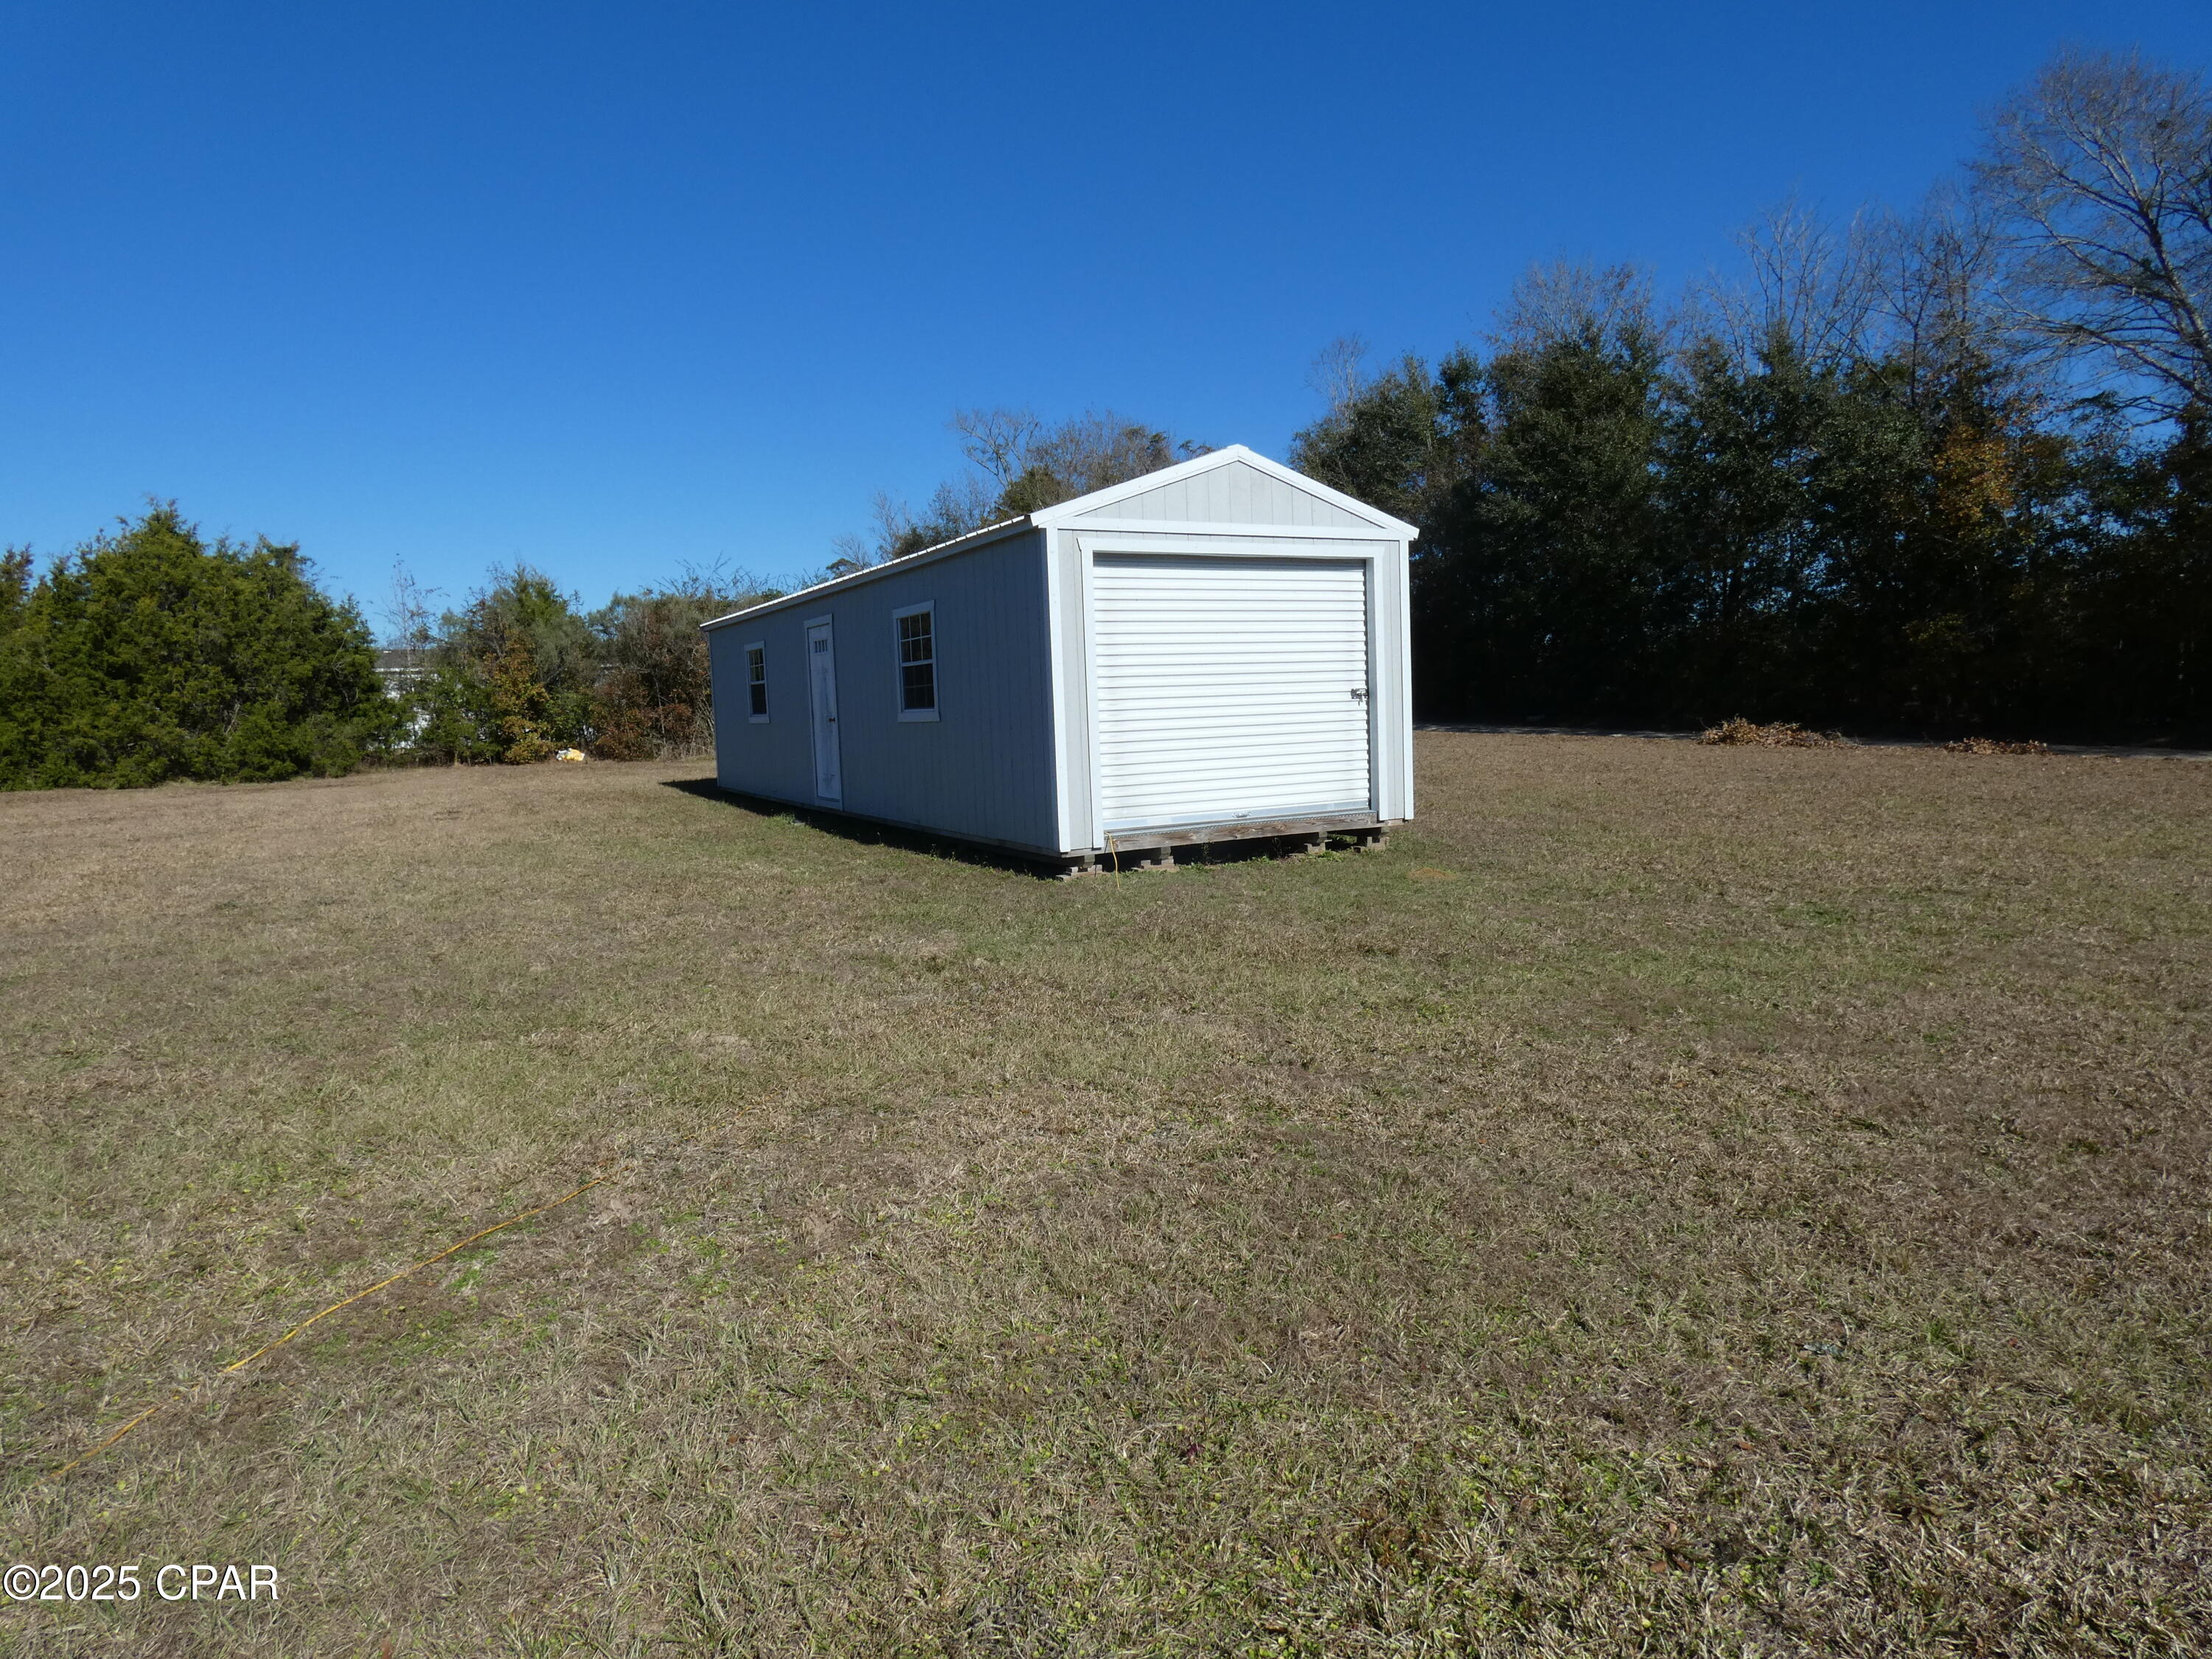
top-left (708, 531), bottom-right (1062, 852)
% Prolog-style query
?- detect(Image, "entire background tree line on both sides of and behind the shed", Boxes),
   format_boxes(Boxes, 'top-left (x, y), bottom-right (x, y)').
top-left (0, 45), bottom-right (2212, 787)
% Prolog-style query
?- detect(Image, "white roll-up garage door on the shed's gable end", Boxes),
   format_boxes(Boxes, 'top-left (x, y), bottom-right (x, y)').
top-left (1093, 555), bottom-right (1371, 834)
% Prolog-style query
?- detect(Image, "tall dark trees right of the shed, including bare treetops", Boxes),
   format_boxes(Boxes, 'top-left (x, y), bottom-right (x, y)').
top-left (1292, 55), bottom-right (2212, 737)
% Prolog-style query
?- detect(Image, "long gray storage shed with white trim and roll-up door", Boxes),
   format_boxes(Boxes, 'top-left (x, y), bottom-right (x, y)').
top-left (706, 445), bottom-right (1418, 867)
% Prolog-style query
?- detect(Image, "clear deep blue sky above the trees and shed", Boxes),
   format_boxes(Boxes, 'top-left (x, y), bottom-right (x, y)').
top-left (0, 0), bottom-right (2212, 611)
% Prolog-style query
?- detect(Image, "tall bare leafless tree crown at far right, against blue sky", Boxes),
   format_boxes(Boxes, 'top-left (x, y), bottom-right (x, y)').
top-left (1973, 53), bottom-right (2212, 418)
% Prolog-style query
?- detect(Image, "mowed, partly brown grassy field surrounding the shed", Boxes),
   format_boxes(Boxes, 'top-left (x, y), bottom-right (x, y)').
top-left (0, 734), bottom-right (2212, 1655)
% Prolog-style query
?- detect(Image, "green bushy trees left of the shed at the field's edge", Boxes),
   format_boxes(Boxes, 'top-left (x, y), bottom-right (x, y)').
top-left (0, 502), bottom-right (774, 790)
